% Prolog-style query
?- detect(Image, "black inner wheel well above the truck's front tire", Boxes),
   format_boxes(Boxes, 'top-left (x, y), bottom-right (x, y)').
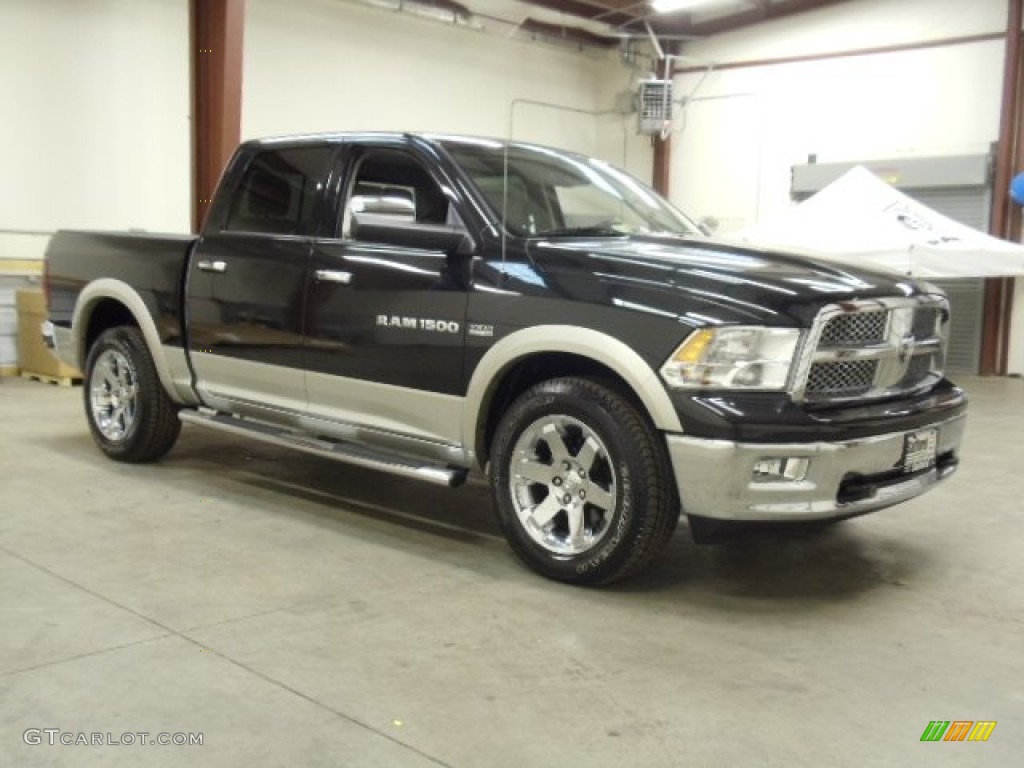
top-left (476, 352), bottom-right (650, 467)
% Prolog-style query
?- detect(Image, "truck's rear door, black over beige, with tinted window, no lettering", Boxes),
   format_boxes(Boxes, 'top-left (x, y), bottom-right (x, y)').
top-left (187, 144), bottom-right (333, 421)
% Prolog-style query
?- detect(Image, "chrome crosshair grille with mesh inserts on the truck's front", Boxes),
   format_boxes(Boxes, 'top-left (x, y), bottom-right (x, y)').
top-left (795, 296), bottom-right (949, 403)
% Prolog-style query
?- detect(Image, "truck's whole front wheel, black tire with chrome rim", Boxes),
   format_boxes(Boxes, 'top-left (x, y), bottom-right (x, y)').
top-left (490, 378), bottom-right (679, 585)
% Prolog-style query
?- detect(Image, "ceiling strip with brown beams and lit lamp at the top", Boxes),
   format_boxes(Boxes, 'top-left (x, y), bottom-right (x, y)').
top-left (512, 0), bottom-right (850, 45)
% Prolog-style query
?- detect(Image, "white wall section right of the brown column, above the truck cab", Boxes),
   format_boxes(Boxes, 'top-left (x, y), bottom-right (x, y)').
top-left (242, 0), bottom-right (651, 179)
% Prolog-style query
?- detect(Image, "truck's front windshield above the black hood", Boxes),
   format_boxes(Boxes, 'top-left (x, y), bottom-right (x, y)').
top-left (444, 140), bottom-right (700, 238)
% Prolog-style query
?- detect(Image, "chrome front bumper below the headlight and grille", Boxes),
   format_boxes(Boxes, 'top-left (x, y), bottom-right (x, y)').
top-left (667, 415), bottom-right (967, 521)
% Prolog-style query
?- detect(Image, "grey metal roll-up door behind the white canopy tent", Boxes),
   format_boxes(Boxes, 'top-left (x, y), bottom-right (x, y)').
top-left (793, 155), bottom-right (991, 375)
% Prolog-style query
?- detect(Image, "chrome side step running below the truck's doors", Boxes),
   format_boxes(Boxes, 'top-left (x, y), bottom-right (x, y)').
top-left (178, 410), bottom-right (468, 487)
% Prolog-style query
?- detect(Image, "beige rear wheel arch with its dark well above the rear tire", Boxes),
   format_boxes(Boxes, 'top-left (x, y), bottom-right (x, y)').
top-left (72, 278), bottom-right (190, 402)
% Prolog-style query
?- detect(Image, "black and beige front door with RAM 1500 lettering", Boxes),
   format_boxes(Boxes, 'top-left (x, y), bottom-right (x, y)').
top-left (305, 140), bottom-right (467, 455)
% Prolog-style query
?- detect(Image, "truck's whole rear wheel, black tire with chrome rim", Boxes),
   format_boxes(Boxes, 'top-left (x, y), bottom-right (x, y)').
top-left (83, 326), bottom-right (181, 463)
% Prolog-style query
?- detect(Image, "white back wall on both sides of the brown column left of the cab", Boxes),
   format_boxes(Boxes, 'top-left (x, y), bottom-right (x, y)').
top-left (0, 0), bottom-right (651, 266)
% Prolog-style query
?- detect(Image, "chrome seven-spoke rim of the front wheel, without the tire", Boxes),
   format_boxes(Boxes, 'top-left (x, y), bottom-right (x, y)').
top-left (509, 414), bottom-right (615, 556)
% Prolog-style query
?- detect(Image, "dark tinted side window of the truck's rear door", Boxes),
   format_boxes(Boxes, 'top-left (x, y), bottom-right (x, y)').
top-left (224, 146), bottom-right (331, 234)
